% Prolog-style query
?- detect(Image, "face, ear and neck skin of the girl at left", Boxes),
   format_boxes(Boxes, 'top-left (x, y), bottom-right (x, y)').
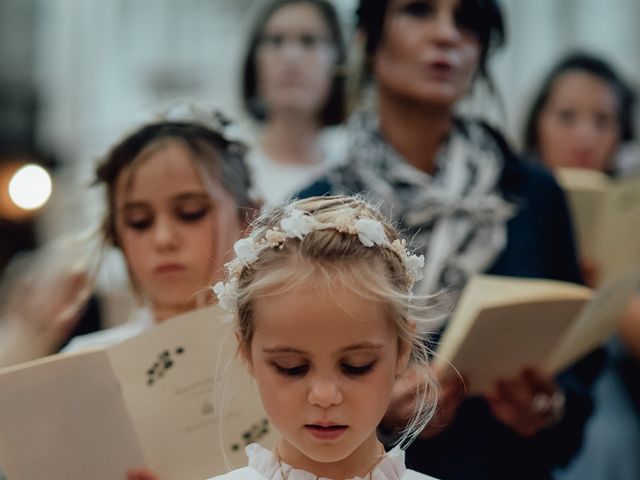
top-left (115, 141), bottom-right (240, 322)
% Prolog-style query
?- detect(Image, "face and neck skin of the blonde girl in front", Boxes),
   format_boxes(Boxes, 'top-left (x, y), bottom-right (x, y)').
top-left (241, 275), bottom-right (409, 478)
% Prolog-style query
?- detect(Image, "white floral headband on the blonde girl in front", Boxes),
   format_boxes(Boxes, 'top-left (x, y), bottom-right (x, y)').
top-left (213, 208), bottom-right (424, 312)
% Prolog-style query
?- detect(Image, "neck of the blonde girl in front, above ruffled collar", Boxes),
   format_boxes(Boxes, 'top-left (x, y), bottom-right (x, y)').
top-left (275, 432), bottom-right (385, 479)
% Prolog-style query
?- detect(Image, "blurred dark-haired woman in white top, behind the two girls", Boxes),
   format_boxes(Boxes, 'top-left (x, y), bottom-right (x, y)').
top-left (242, 0), bottom-right (346, 204)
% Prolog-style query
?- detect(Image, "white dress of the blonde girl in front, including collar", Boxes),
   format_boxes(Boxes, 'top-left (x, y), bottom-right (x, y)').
top-left (209, 443), bottom-right (435, 480)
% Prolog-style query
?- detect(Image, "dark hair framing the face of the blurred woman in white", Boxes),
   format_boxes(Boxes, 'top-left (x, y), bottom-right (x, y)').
top-left (242, 0), bottom-right (347, 126)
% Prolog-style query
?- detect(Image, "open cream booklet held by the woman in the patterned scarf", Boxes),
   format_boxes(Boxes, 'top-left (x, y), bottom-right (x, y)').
top-left (434, 270), bottom-right (640, 394)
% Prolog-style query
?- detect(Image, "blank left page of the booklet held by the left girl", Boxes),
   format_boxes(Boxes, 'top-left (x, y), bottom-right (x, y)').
top-left (0, 351), bottom-right (145, 480)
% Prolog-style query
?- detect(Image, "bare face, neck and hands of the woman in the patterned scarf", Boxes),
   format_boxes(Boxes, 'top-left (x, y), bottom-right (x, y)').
top-left (373, 0), bottom-right (558, 437)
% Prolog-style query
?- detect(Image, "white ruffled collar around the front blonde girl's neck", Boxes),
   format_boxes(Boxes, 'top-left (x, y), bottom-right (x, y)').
top-left (245, 443), bottom-right (407, 480)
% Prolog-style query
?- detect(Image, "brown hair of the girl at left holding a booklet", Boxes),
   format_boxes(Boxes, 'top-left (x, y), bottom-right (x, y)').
top-left (94, 121), bottom-right (254, 246)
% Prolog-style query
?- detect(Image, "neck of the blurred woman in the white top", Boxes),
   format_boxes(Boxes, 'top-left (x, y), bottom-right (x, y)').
top-left (261, 114), bottom-right (322, 165)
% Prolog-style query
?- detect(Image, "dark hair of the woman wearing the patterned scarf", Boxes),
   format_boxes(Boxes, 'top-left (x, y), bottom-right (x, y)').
top-left (356, 0), bottom-right (506, 91)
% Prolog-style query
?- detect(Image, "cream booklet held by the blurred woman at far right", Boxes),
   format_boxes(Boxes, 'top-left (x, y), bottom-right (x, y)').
top-left (556, 168), bottom-right (640, 280)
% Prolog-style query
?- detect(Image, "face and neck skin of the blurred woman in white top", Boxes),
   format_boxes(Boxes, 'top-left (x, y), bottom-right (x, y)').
top-left (256, 2), bottom-right (336, 164)
